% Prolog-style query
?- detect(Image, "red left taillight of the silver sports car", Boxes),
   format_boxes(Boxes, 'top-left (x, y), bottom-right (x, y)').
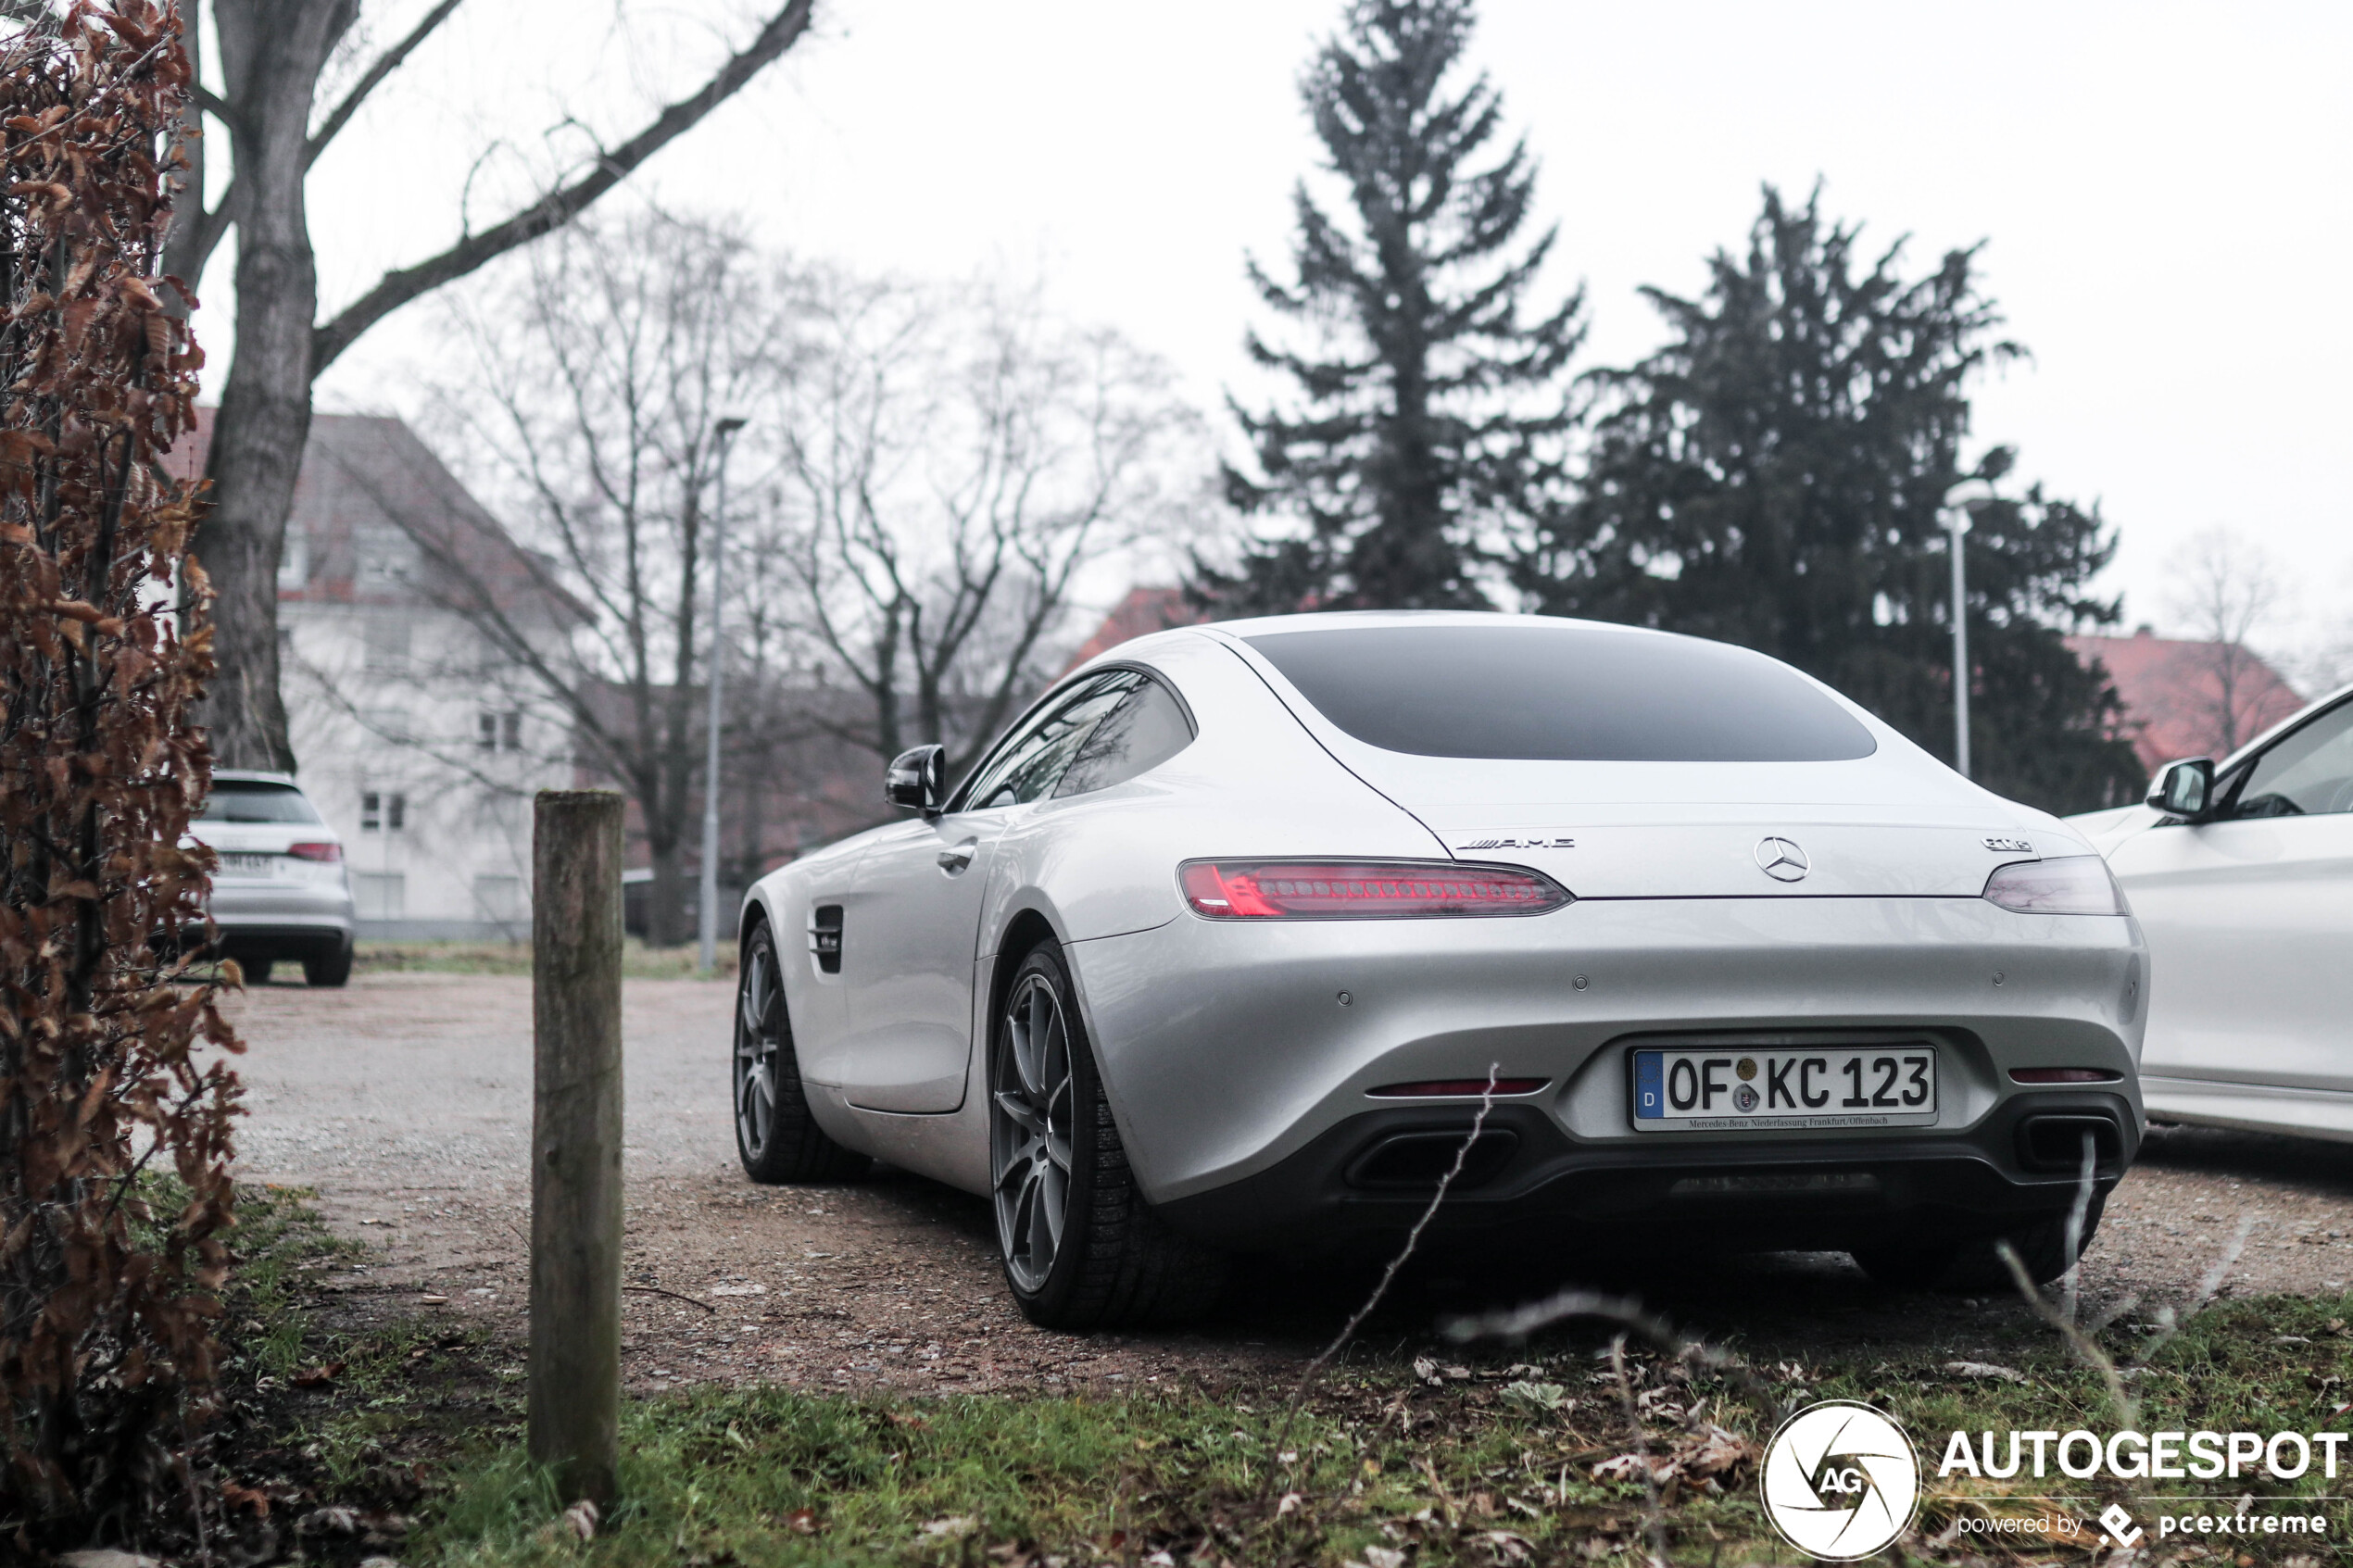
top-left (1176, 860), bottom-right (1572, 919)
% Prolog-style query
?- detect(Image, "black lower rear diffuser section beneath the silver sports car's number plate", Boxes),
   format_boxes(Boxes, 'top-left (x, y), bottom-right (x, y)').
top-left (1163, 1093), bottom-right (2139, 1253)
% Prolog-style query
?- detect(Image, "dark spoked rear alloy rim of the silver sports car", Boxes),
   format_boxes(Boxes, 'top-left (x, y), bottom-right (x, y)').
top-left (988, 973), bottom-right (1076, 1293)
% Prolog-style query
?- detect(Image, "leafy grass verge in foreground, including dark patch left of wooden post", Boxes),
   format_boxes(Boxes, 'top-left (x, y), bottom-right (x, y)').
top-left (219, 1187), bottom-right (2353, 1568)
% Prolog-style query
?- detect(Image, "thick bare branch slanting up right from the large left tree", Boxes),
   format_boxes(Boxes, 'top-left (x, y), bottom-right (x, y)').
top-left (310, 0), bottom-right (814, 379)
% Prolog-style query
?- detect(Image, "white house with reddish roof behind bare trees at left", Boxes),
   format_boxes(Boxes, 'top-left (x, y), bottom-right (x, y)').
top-left (174, 409), bottom-right (574, 940)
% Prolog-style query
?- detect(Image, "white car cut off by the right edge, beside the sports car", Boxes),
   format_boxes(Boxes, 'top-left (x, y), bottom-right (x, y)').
top-left (2069, 686), bottom-right (2353, 1138)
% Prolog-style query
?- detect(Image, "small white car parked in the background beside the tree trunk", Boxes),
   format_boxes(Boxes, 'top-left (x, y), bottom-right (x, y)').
top-left (188, 769), bottom-right (360, 985)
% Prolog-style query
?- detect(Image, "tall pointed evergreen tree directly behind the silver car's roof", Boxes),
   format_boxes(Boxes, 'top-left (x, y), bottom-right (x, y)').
top-left (1193, 0), bottom-right (1583, 613)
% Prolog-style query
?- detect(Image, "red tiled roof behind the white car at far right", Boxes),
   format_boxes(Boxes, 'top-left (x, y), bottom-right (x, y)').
top-left (2066, 630), bottom-right (2304, 773)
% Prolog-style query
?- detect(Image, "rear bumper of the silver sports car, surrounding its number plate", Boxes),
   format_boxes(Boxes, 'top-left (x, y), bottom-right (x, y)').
top-left (1068, 898), bottom-right (2148, 1246)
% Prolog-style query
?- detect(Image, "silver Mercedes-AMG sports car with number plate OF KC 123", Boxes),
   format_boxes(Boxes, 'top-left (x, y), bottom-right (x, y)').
top-left (734, 613), bottom-right (2148, 1328)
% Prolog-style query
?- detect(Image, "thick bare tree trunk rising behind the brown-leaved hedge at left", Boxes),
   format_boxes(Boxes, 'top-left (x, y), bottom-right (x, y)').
top-left (195, 0), bottom-right (360, 773)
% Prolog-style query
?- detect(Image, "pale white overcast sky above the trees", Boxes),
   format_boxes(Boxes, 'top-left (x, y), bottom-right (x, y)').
top-left (271, 0), bottom-right (2353, 677)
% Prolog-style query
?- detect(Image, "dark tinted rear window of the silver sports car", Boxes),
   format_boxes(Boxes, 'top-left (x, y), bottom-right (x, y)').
top-left (1245, 621), bottom-right (1878, 761)
